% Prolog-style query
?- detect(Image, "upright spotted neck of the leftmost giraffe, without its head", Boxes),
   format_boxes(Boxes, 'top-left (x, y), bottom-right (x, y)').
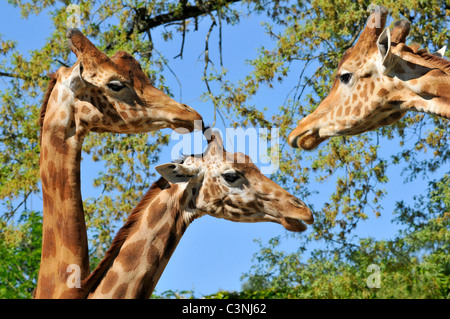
top-left (35, 79), bottom-right (89, 298)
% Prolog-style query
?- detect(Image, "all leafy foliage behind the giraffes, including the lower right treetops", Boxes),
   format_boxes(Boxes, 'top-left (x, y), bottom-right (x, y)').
top-left (0, 0), bottom-right (450, 298)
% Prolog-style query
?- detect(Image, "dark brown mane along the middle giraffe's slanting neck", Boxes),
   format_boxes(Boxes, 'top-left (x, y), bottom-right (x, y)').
top-left (77, 177), bottom-right (169, 298)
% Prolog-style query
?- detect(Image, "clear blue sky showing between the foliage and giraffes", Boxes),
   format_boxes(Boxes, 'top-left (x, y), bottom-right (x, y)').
top-left (0, 2), bottom-right (443, 296)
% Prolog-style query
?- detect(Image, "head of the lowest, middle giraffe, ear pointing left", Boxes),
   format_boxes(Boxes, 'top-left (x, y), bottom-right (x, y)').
top-left (156, 131), bottom-right (314, 231)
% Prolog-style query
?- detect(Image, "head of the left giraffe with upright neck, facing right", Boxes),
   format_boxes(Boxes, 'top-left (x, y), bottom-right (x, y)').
top-left (44, 29), bottom-right (202, 133)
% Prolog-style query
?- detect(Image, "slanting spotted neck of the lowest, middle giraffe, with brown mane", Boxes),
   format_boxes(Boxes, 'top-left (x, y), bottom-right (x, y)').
top-left (83, 179), bottom-right (195, 299)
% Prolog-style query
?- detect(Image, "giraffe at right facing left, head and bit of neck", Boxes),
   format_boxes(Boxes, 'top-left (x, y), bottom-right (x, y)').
top-left (288, 6), bottom-right (450, 150)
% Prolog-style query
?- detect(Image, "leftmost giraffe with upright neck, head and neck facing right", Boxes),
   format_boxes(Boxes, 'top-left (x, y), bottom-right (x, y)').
top-left (35, 29), bottom-right (203, 298)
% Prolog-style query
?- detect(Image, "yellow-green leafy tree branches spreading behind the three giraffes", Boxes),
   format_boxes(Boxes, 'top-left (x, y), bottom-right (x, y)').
top-left (0, 0), bottom-right (450, 296)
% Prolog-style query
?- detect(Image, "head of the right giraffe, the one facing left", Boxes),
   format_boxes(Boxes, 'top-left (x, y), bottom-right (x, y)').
top-left (288, 6), bottom-right (442, 150)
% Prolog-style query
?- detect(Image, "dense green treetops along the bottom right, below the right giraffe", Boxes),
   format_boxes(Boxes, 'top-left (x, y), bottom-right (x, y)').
top-left (208, 175), bottom-right (450, 299)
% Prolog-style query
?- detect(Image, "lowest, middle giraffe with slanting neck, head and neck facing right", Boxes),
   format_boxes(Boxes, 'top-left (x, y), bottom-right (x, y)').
top-left (74, 133), bottom-right (314, 299)
